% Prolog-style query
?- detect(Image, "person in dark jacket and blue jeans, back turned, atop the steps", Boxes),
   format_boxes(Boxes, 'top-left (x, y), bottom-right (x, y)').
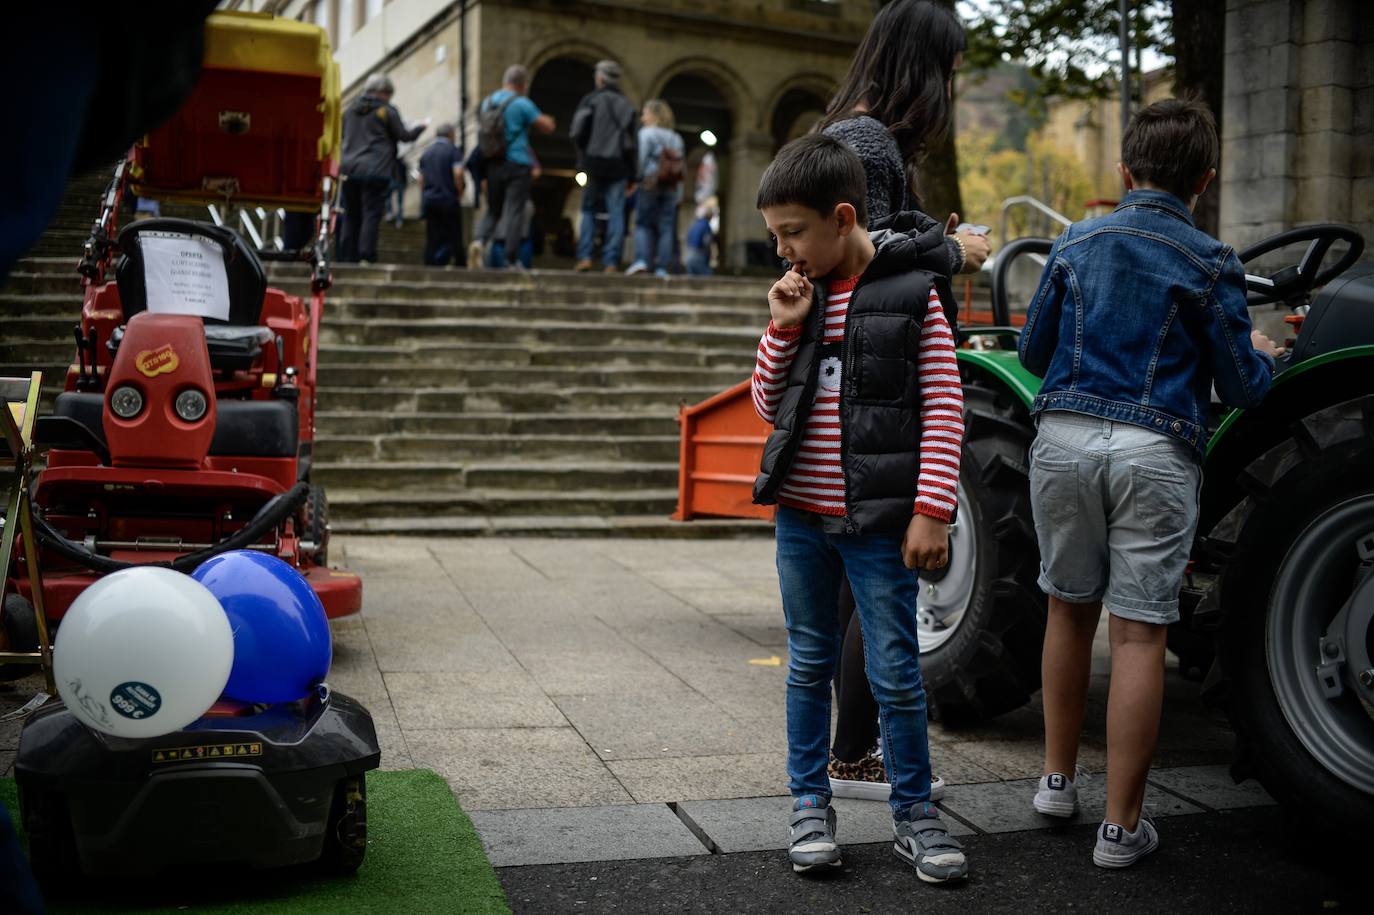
top-left (570, 60), bottom-right (636, 273)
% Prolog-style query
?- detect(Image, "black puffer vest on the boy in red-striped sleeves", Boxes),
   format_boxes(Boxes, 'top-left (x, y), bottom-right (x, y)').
top-left (754, 213), bottom-right (955, 534)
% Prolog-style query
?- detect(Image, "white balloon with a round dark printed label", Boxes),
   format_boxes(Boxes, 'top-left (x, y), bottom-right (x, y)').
top-left (52, 566), bottom-right (234, 738)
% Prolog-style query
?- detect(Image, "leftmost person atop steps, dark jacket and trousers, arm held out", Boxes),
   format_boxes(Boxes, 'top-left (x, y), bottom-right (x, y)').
top-left (338, 73), bottom-right (429, 264)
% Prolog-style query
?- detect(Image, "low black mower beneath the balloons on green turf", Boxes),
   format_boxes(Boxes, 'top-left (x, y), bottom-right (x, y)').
top-left (15, 687), bottom-right (381, 877)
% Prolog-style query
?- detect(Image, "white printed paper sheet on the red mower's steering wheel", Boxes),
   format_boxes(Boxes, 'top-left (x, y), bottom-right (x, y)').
top-left (139, 232), bottom-right (229, 321)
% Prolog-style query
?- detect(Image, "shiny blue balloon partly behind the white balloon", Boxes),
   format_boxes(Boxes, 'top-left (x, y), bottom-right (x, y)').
top-left (191, 550), bottom-right (334, 702)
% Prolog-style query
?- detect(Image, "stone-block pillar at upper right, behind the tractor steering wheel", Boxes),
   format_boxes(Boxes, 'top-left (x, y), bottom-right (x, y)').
top-left (1221, 0), bottom-right (1374, 257)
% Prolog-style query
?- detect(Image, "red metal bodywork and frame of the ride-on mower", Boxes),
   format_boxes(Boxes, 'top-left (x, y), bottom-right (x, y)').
top-left (16, 67), bottom-right (363, 620)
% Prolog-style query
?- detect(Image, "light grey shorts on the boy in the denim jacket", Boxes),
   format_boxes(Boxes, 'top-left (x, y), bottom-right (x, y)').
top-left (1031, 411), bottom-right (1202, 625)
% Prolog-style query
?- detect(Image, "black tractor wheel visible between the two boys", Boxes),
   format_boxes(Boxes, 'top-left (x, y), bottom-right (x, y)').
top-left (916, 383), bottom-right (1046, 727)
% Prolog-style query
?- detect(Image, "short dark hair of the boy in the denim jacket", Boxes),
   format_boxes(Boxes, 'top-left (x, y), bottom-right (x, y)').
top-left (1121, 96), bottom-right (1219, 201)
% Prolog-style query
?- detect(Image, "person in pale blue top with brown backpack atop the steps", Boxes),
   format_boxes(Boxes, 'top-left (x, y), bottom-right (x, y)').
top-left (625, 99), bottom-right (686, 276)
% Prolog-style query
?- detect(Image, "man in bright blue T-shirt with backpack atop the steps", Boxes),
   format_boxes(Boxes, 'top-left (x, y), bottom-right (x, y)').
top-left (477, 63), bottom-right (554, 267)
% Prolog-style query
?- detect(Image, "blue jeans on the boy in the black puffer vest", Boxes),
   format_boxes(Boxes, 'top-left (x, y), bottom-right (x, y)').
top-left (778, 506), bottom-right (930, 816)
